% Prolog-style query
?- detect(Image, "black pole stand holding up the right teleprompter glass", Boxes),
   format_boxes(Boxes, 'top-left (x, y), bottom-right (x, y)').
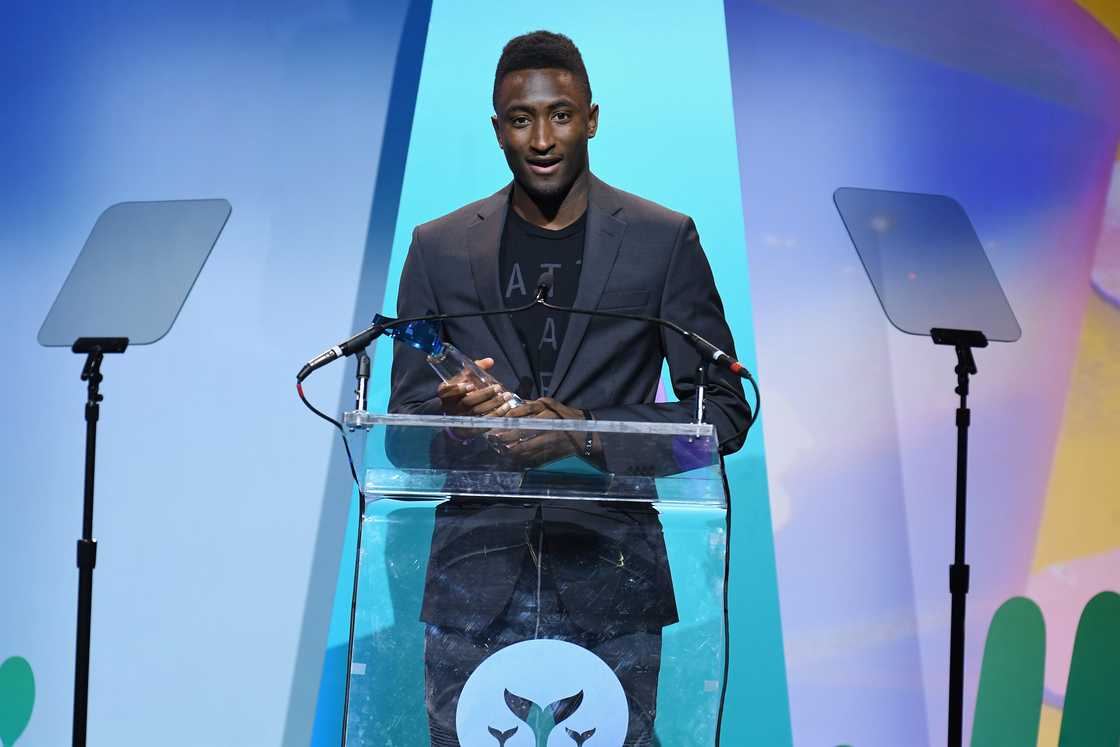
top-left (930, 328), bottom-right (988, 747)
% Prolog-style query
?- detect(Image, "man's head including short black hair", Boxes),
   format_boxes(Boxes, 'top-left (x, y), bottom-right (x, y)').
top-left (493, 31), bottom-right (599, 202)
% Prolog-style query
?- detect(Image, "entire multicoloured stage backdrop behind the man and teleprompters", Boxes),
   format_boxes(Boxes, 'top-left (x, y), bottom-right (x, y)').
top-left (0, 0), bottom-right (1120, 747)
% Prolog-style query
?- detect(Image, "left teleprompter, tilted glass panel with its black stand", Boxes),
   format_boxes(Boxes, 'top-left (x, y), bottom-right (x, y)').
top-left (38, 199), bottom-right (231, 747)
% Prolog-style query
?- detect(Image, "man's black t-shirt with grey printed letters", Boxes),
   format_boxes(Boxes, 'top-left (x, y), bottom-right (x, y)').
top-left (498, 206), bottom-right (587, 396)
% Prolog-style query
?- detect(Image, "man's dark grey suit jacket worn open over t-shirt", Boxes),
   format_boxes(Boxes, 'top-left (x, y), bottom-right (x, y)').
top-left (389, 176), bottom-right (750, 629)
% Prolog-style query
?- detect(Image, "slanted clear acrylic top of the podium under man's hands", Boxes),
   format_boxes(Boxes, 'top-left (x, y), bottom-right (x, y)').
top-left (343, 411), bottom-right (727, 507)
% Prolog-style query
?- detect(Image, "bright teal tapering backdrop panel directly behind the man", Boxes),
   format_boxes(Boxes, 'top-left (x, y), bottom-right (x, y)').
top-left (316, 0), bottom-right (791, 745)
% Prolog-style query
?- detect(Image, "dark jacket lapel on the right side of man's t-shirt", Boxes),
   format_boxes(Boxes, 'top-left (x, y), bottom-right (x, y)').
top-left (549, 176), bottom-right (626, 401)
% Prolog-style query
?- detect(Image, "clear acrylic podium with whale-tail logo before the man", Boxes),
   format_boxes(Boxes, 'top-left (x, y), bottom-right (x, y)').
top-left (344, 412), bottom-right (728, 747)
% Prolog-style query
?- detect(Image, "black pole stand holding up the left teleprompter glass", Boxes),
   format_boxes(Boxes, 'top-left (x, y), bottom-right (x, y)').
top-left (71, 337), bottom-right (129, 747)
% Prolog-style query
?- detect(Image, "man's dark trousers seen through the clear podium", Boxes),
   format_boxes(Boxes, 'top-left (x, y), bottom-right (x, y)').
top-left (424, 535), bottom-right (661, 747)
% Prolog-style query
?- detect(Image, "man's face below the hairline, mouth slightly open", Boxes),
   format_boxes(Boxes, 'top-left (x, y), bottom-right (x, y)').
top-left (493, 67), bottom-right (599, 200)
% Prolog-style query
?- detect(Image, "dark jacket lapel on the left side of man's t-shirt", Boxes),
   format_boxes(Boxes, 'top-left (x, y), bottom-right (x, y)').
top-left (467, 186), bottom-right (531, 395)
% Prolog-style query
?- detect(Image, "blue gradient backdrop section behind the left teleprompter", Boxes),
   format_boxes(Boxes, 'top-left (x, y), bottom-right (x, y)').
top-left (0, 0), bottom-right (427, 747)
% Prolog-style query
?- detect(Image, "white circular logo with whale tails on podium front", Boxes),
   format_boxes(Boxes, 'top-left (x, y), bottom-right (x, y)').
top-left (455, 639), bottom-right (629, 747)
